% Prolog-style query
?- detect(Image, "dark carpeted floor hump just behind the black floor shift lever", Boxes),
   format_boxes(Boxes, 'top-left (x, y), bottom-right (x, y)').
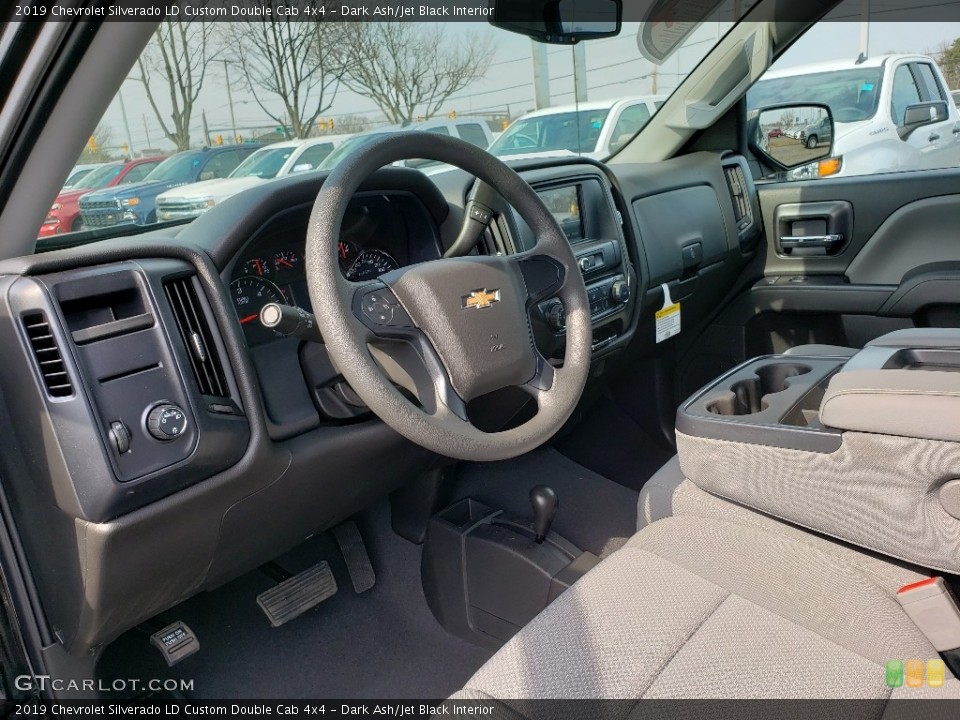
top-left (454, 448), bottom-right (637, 556)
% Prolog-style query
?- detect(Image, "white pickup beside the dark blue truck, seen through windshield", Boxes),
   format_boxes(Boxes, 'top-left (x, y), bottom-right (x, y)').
top-left (157, 135), bottom-right (350, 222)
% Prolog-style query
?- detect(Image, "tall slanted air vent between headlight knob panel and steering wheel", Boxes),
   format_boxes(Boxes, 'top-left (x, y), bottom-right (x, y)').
top-left (164, 276), bottom-right (230, 397)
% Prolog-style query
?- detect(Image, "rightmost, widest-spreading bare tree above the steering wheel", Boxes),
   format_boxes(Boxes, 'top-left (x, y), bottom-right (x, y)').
top-left (339, 22), bottom-right (494, 123)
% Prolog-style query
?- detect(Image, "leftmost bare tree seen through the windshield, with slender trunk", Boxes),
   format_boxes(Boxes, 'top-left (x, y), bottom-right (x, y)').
top-left (135, 20), bottom-right (218, 150)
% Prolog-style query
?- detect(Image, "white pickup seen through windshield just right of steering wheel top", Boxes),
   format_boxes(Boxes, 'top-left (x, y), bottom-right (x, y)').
top-left (490, 95), bottom-right (664, 160)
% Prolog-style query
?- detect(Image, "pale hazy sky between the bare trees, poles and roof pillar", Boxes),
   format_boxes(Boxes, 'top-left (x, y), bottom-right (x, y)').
top-left (95, 11), bottom-right (960, 152)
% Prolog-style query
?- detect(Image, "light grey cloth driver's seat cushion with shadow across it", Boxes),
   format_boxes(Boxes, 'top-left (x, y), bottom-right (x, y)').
top-left (455, 516), bottom-right (960, 700)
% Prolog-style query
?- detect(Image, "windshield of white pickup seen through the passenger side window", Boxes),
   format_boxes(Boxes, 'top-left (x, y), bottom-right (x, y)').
top-left (747, 68), bottom-right (883, 122)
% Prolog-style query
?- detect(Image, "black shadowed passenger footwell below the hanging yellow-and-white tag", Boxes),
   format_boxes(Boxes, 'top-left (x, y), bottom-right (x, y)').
top-left (556, 398), bottom-right (675, 492)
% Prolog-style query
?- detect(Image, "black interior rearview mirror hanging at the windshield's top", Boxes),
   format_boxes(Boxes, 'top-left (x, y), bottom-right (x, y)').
top-left (490, 0), bottom-right (623, 45)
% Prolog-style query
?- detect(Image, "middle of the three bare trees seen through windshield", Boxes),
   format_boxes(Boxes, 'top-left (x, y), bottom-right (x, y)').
top-left (230, 0), bottom-right (343, 138)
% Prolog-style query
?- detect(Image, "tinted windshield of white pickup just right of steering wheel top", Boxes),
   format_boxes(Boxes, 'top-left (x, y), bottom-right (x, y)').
top-left (490, 109), bottom-right (610, 156)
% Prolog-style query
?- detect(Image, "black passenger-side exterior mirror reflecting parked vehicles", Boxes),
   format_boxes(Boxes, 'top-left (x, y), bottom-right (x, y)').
top-left (748, 103), bottom-right (833, 170)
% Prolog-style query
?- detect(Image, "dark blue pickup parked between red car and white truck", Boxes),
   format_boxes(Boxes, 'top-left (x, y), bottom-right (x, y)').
top-left (80, 144), bottom-right (262, 228)
